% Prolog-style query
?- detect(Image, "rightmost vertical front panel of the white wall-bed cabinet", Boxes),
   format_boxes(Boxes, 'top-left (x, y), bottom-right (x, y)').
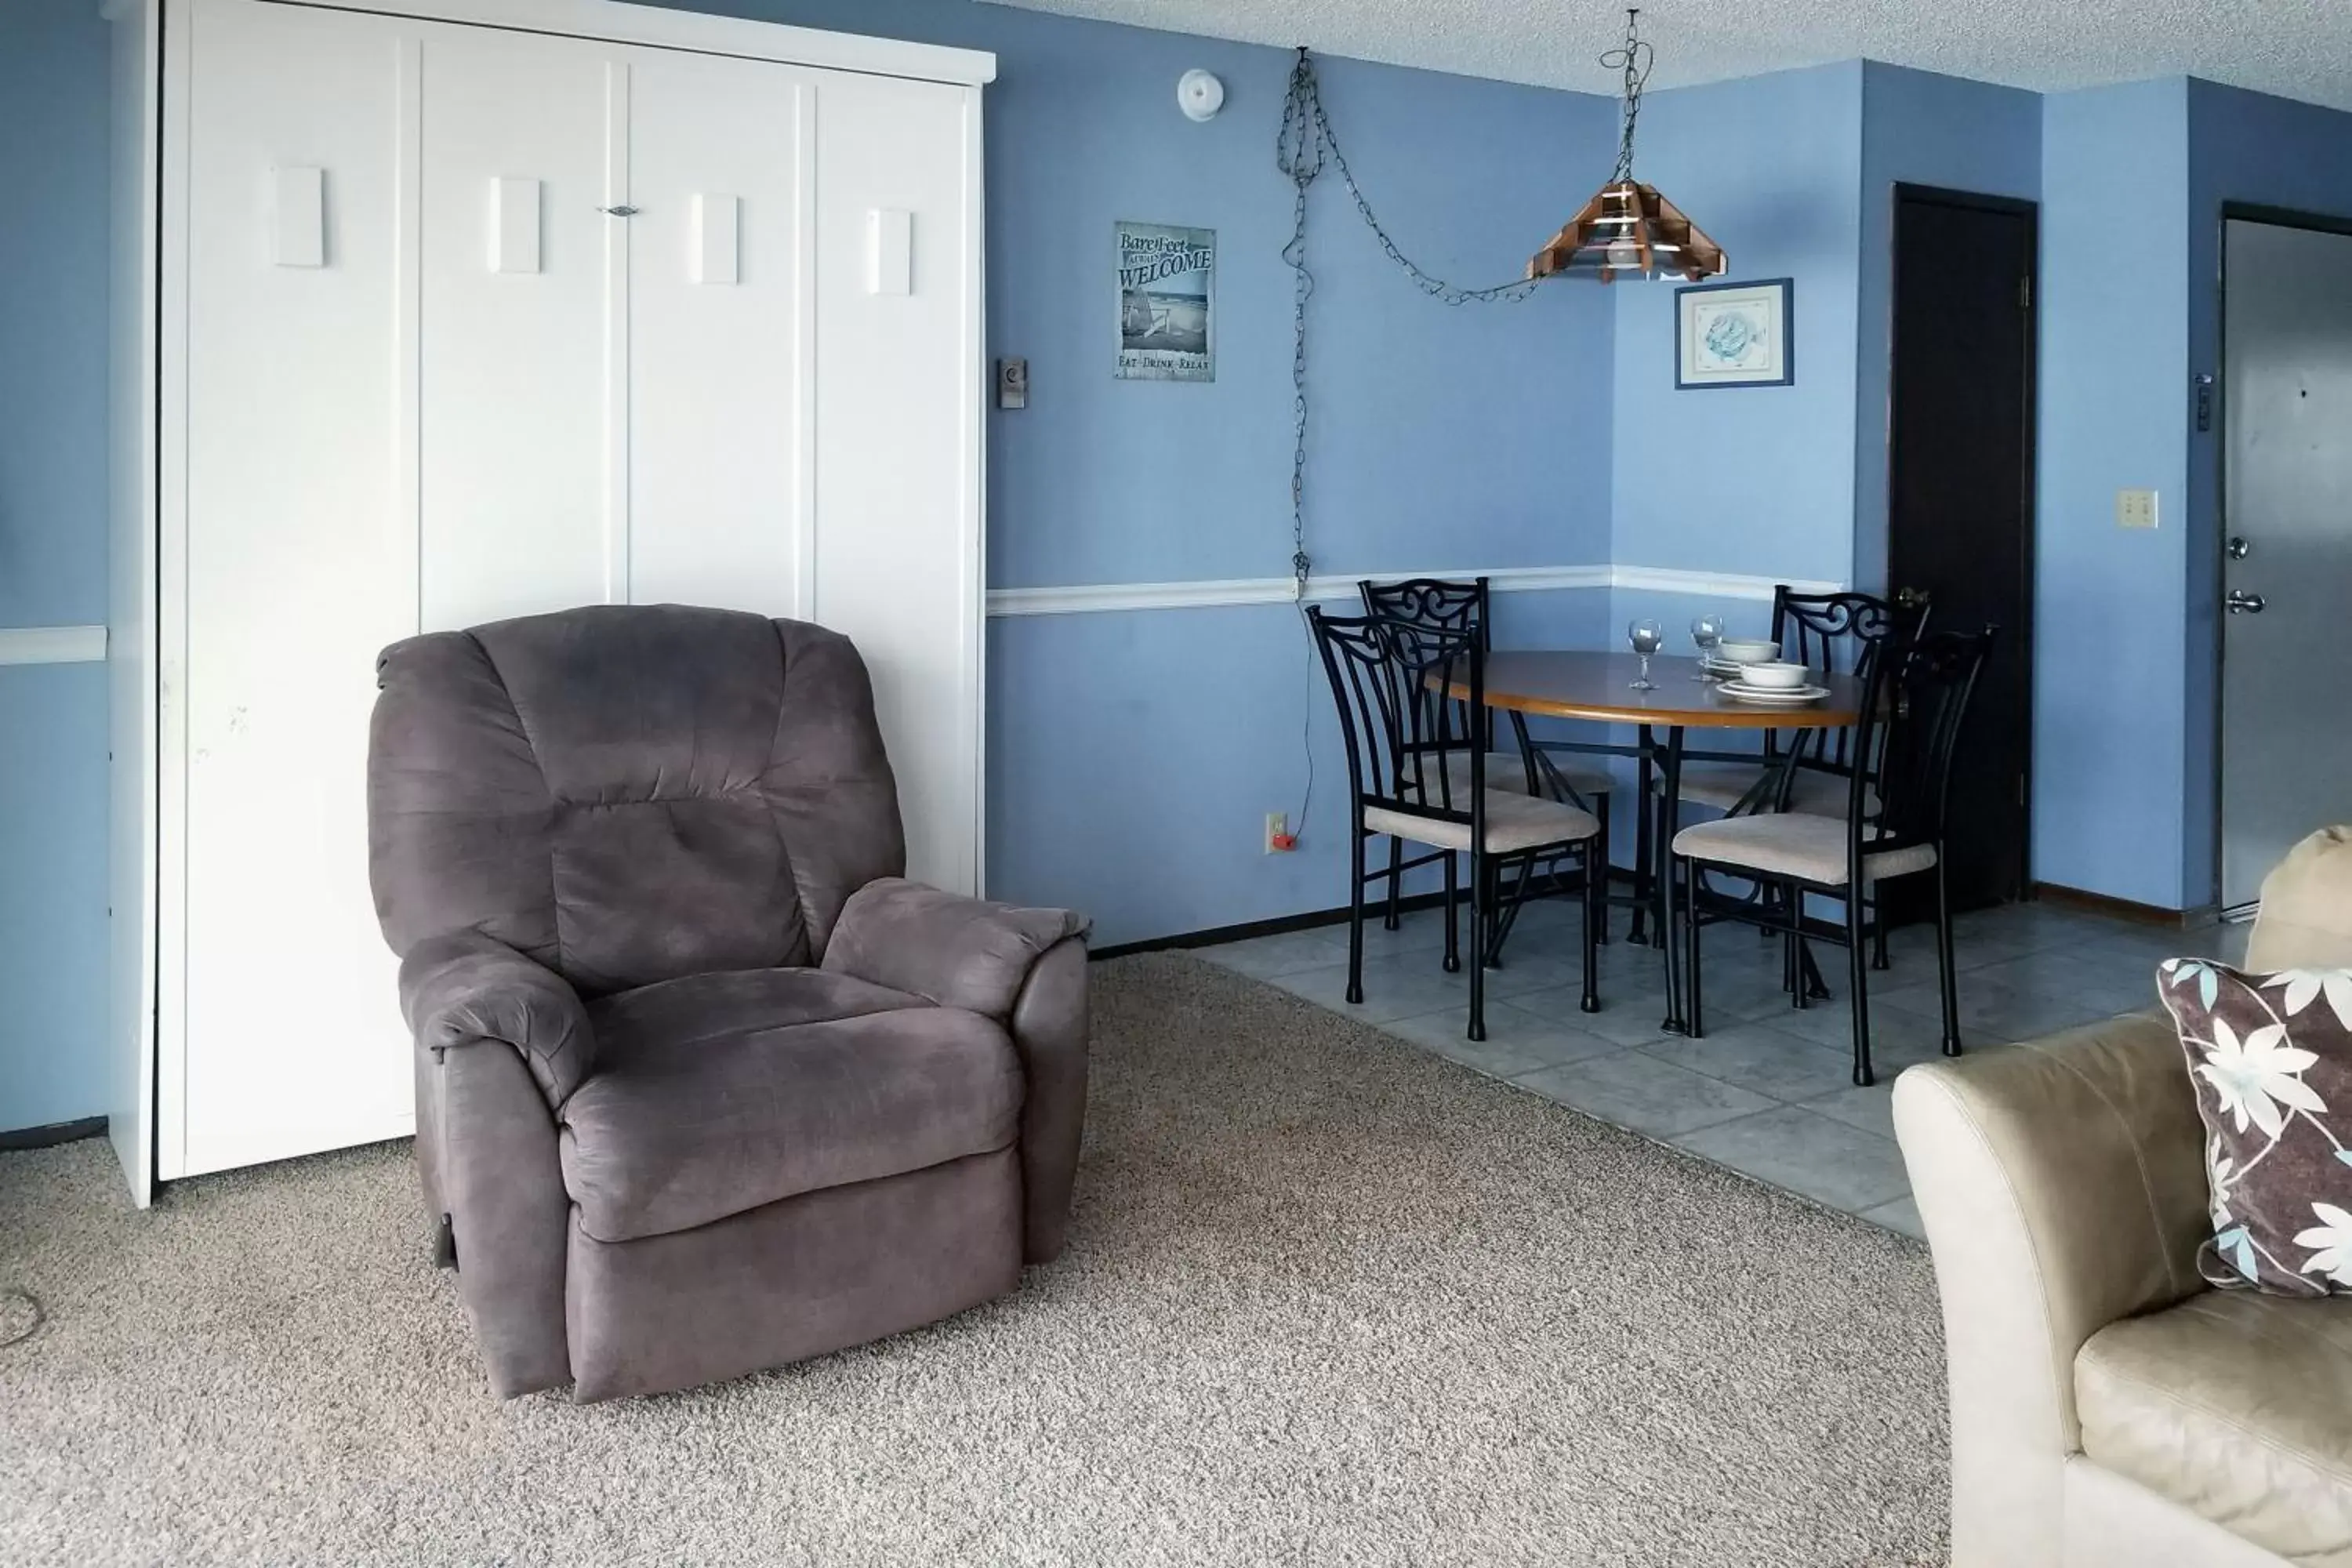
top-left (816, 75), bottom-right (981, 893)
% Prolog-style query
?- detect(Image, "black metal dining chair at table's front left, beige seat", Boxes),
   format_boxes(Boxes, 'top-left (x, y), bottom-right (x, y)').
top-left (1308, 607), bottom-right (1606, 1039)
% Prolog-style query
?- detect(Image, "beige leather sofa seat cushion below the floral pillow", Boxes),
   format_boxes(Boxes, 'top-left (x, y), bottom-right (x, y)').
top-left (2074, 1290), bottom-right (2352, 1563)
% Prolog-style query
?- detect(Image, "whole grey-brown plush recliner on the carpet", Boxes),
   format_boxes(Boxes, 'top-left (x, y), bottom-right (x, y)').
top-left (367, 607), bottom-right (1087, 1399)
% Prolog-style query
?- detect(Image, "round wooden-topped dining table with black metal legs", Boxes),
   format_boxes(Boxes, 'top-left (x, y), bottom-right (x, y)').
top-left (1446, 649), bottom-right (1863, 1034)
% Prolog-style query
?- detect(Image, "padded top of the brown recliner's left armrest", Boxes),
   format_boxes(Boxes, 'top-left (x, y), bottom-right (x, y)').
top-left (400, 931), bottom-right (595, 1107)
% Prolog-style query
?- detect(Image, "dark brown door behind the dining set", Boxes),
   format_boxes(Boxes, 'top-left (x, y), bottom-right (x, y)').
top-left (1886, 186), bottom-right (2034, 909)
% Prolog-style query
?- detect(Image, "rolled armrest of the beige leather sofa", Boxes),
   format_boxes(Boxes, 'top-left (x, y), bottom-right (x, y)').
top-left (1893, 1015), bottom-right (2213, 1568)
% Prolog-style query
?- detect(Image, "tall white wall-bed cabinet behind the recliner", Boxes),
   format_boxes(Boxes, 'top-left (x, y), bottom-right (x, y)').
top-left (108, 0), bottom-right (995, 1201)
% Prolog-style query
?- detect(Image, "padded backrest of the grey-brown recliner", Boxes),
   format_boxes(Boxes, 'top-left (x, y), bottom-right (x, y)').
top-left (367, 604), bottom-right (906, 994)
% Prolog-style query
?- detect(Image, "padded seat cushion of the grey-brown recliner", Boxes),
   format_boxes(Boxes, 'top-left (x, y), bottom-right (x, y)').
top-left (562, 968), bottom-right (1023, 1241)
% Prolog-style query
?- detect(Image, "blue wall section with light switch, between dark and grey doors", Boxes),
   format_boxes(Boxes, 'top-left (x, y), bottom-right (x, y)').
top-left (2032, 78), bottom-right (2190, 907)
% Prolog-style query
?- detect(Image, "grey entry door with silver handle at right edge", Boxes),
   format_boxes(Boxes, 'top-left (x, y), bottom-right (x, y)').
top-left (2220, 221), bottom-right (2352, 907)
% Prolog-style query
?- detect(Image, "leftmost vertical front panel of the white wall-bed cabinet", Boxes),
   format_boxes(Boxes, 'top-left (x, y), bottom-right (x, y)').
top-left (179, 0), bottom-right (416, 1175)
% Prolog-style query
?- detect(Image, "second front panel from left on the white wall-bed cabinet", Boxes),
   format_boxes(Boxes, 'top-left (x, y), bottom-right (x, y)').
top-left (416, 26), bottom-right (628, 630)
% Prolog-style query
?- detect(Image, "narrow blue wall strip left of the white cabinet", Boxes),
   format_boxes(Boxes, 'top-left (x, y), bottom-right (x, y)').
top-left (0, 0), bottom-right (108, 1128)
